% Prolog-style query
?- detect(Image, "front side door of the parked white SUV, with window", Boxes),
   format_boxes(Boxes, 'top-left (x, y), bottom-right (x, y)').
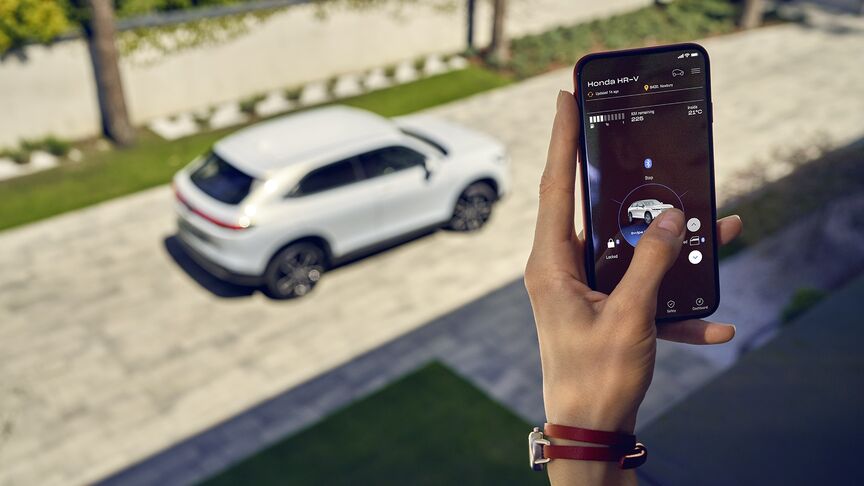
top-left (360, 145), bottom-right (442, 238)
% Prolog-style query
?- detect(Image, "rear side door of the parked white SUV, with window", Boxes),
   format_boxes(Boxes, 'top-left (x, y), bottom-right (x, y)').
top-left (286, 157), bottom-right (378, 256)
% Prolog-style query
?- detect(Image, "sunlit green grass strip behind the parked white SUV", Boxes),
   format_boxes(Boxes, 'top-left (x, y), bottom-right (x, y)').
top-left (0, 67), bottom-right (510, 230)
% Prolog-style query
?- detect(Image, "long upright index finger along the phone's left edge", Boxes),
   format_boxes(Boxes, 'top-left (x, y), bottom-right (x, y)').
top-left (534, 90), bottom-right (580, 258)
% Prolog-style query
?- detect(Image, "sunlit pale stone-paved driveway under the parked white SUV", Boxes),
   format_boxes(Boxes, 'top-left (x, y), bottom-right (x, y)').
top-left (0, 16), bottom-right (864, 485)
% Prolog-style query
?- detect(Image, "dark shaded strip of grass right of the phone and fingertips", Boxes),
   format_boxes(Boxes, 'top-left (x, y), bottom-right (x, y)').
top-left (718, 140), bottom-right (864, 258)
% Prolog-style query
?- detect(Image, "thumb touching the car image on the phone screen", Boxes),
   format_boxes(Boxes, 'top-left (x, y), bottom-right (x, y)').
top-left (610, 208), bottom-right (684, 309)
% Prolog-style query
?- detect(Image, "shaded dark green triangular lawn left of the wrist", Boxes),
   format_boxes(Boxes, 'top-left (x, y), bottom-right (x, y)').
top-left (204, 363), bottom-right (548, 486)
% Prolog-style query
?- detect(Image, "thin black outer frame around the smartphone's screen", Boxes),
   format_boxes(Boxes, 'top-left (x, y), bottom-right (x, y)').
top-left (573, 42), bottom-right (720, 322)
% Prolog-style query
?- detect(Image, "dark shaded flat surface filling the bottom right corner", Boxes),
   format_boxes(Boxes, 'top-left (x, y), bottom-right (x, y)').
top-left (639, 276), bottom-right (864, 486)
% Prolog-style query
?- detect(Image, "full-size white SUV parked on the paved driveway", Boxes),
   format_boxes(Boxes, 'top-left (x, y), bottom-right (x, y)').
top-left (174, 106), bottom-right (509, 298)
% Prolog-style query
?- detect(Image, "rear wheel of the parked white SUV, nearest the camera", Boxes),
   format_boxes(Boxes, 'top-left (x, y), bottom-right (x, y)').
top-left (264, 241), bottom-right (327, 299)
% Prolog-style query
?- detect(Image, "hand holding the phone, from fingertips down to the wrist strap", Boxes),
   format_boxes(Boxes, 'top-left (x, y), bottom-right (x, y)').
top-left (525, 91), bottom-right (742, 438)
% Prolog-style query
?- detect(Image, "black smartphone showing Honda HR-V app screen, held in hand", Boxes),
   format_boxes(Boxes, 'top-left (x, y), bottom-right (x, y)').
top-left (574, 43), bottom-right (720, 320)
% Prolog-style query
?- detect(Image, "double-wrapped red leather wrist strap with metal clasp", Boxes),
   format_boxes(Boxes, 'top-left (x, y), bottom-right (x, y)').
top-left (528, 423), bottom-right (648, 470)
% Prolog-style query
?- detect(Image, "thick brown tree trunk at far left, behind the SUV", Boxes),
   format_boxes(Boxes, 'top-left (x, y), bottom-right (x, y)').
top-left (82, 0), bottom-right (135, 146)
